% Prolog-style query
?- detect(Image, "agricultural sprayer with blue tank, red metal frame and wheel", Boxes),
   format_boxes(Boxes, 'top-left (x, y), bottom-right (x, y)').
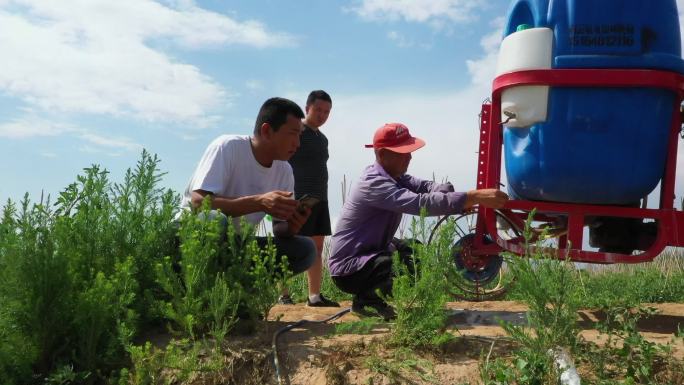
top-left (431, 0), bottom-right (684, 300)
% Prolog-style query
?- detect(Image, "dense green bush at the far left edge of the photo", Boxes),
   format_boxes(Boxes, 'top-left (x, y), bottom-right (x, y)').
top-left (0, 196), bottom-right (74, 374)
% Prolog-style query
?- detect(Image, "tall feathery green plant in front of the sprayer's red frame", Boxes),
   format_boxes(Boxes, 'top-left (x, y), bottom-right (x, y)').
top-left (480, 212), bottom-right (581, 384)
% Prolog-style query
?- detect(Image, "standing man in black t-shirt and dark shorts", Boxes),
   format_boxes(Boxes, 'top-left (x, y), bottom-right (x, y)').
top-left (280, 90), bottom-right (340, 307)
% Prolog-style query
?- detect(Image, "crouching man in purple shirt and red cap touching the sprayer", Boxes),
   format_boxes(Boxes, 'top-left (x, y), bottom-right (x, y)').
top-left (328, 123), bottom-right (508, 319)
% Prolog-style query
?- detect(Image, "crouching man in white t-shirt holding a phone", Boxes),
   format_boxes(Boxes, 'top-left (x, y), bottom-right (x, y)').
top-left (182, 98), bottom-right (316, 282)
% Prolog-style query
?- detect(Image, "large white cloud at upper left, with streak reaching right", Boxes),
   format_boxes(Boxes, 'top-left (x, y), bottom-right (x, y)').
top-left (0, 0), bottom-right (294, 125)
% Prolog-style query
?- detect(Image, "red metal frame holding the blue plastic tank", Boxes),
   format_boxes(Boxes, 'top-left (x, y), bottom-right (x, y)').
top-left (473, 69), bottom-right (684, 263)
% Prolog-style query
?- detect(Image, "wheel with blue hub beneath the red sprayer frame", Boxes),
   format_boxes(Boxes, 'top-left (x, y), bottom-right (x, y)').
top-left (428, 211), bottom-right (522, 302)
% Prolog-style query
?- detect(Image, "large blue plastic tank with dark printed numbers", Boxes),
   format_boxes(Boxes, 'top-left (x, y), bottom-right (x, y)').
top-left (504, 0), bottom-right (684, 205)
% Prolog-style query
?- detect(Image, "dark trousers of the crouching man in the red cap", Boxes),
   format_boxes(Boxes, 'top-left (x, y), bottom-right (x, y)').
top-left (332, 238), bottom-right (415, 303)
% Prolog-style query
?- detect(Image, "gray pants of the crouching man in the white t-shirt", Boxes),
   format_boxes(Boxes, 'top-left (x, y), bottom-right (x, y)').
top-left (199, 210), bottom-right (316, 274)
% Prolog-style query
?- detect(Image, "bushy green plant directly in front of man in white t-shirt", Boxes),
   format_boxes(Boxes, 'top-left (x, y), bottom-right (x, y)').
top-left (156, 200), bottom-right (289, 340)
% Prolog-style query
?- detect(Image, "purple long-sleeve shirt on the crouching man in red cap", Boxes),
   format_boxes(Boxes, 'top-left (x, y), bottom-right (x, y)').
top-left (328, 163), bottom-right (466, 277)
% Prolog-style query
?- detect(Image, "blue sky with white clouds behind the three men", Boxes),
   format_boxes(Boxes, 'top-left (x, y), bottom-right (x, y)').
top-left (0, 0), bottom-right (684, 224)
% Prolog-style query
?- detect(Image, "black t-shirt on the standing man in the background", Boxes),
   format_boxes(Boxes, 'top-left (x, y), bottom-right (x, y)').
top-left (290, 125), bottom-right (329, 201)
